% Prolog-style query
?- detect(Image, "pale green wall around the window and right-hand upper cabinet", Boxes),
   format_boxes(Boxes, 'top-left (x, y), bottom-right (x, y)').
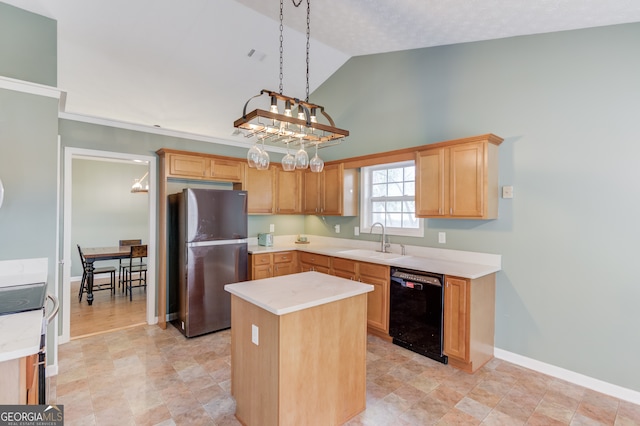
top-left (306, 24), bottom-right (640, 391)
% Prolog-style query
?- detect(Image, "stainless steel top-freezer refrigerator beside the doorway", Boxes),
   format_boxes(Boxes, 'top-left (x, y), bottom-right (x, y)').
top-left (167, 188), bottom-right (247, 337)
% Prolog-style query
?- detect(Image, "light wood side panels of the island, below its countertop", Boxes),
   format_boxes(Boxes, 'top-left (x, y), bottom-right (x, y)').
top-left (231, 294), bottom-right (367, 426)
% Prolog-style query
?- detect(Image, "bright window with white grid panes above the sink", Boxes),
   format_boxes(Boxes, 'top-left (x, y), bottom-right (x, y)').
top-left (360, 161), bottom-right (424, 237)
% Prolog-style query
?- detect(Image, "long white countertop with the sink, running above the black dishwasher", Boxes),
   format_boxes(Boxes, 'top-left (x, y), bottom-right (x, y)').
top-left (249, 237), bottom-right (501, 279)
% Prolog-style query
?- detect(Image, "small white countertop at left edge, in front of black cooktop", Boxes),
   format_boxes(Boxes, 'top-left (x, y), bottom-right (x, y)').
top-left (0, 309), bottom-right (44, 362)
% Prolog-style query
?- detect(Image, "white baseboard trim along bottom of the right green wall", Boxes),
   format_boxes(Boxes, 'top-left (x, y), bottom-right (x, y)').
top-left (493, 348), bottom-right (640, 405)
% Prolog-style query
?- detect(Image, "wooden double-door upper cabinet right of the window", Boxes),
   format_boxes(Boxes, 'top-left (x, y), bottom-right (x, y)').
top-left (416, 134), bottom-right (502, 219)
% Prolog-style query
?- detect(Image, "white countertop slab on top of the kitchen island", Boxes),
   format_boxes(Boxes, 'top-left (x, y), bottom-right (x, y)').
top-left (224, 272), bottom-right (373, 315)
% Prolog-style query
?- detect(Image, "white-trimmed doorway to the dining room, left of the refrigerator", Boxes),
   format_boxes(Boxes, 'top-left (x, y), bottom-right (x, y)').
top-left (60, 148), bottom-right (157, 343)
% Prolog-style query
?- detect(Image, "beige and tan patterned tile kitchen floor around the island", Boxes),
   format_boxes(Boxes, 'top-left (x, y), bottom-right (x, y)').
top-left (49, 325), bottom-right (640, 426)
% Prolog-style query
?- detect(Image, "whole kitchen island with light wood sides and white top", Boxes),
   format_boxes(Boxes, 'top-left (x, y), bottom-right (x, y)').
top-left (225, 272), bottom-right (373, 426)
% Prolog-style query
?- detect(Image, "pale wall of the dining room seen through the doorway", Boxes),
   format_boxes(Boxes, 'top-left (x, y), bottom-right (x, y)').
top-left (71, 159), bottom-right (149, 277)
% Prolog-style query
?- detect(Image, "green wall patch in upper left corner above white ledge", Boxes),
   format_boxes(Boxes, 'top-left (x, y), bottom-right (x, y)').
top-left (0, 3), bottom-right (58, 87)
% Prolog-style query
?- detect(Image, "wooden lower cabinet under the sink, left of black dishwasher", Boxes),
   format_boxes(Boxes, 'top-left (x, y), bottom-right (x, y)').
top-left (332, 257), bottom-right (389, 339)
